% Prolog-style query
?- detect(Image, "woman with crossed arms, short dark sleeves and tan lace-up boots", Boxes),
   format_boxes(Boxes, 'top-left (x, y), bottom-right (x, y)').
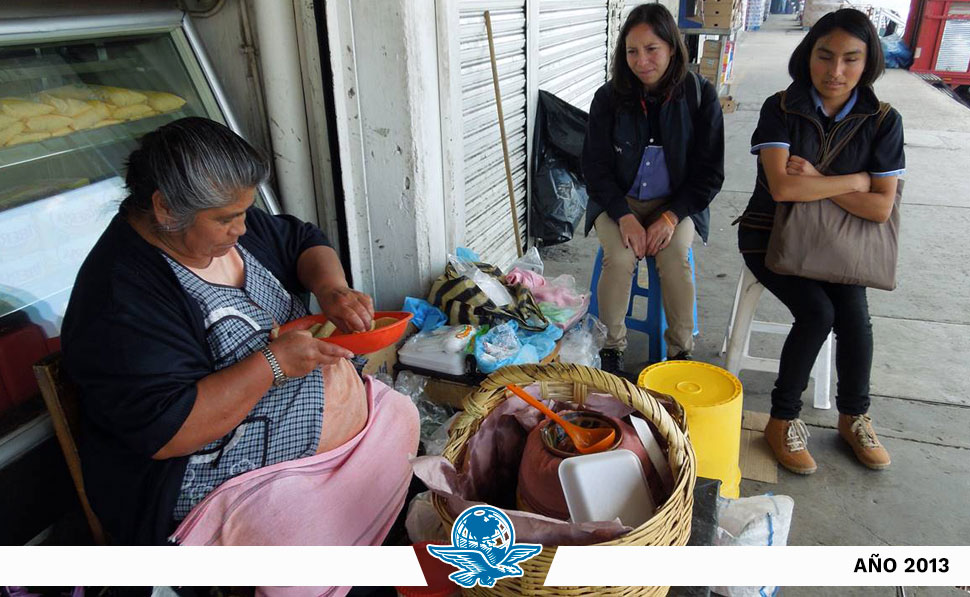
top-left (738, 9), bottom-right (906, 475)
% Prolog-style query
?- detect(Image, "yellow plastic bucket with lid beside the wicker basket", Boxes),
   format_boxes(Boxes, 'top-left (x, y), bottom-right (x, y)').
top-left (637, 361), bottom-right (743, 498)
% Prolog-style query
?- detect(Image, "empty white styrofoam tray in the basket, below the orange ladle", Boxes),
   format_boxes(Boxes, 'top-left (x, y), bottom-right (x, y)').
top-left (559, 450), bottom-right (654, 527)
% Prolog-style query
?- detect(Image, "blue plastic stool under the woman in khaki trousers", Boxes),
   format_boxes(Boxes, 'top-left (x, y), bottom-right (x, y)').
top-left (589, 247), bottom-right (700, 363)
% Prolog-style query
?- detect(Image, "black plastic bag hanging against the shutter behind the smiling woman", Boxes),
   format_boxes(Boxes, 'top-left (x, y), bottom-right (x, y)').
top-left (529, 90), bottom-right (589, 245)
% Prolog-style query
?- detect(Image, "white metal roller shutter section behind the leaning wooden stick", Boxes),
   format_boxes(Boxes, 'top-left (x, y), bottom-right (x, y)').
top-left (459, 0), bottom-right (527, 267)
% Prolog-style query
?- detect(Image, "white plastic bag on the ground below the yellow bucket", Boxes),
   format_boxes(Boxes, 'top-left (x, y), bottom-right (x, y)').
top-left (713, 495), bottom-right (795, 597)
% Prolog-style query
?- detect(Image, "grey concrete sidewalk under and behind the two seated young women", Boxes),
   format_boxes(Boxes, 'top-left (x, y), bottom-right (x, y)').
top-left (542, 15), bottom-right (970, 595)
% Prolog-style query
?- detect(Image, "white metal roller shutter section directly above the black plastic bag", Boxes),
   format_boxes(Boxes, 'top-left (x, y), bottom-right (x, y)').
top-left (539, 0), bottom-right (609, 111)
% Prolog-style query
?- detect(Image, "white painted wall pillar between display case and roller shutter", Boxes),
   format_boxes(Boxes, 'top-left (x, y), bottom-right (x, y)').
top-left (326, 0), bottom-right (448, 309)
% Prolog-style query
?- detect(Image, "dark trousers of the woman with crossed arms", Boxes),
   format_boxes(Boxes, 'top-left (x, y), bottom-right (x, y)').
top-left (743, 253), bottom-right (872, 419)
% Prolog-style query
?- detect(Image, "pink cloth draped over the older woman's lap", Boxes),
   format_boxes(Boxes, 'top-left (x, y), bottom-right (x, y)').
top-left (171, 378), bottom-right (419, 595)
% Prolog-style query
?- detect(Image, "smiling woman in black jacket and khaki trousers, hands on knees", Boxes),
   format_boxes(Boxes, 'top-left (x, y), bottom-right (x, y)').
top-left (583, 4), bottom-right (724, 374)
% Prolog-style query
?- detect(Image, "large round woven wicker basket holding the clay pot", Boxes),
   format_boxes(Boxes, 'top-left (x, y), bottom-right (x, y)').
top-left (432, 364), bottom-right (697, 597)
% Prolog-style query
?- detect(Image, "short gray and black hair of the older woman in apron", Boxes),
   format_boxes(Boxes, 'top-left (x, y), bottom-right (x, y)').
top-left (121, 117), bottom-right (270, 231)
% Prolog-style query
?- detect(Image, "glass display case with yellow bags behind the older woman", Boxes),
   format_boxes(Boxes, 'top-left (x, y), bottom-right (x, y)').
top-left (0, 11), bottom-right (278, 468)
